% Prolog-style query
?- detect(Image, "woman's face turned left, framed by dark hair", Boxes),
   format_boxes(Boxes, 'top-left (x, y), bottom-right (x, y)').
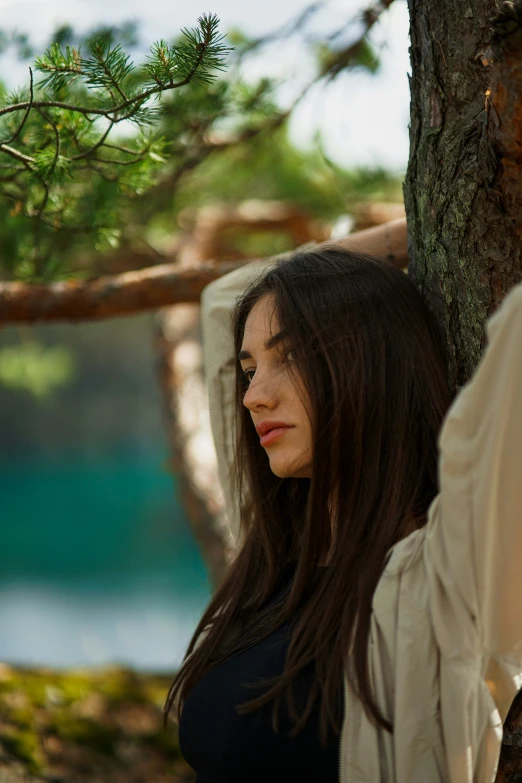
top-left (238, 295), bottom-right (312, 478)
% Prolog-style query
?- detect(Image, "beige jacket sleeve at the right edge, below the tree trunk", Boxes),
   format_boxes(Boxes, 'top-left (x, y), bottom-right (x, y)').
top-left (424, 284), bottom-right (522, 659)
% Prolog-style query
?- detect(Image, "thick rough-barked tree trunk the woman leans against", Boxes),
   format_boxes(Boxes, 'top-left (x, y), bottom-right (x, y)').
top-left (404, 0), bottom-right (522, 390)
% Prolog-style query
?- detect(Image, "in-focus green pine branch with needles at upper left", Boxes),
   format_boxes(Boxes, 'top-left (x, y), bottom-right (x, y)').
top-left (0, 15), bottom-right (231, 251)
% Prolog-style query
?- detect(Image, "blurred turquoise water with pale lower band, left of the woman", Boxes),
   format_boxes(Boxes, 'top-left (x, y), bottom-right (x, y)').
top-left (0, 449), bottom-right (210, 670)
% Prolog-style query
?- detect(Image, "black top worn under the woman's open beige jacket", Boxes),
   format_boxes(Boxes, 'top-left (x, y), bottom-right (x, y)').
top-left (179, 578), bottom-right (344, 783)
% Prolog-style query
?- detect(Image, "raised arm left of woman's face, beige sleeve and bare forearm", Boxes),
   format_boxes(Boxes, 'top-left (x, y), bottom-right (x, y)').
top-left (201, 214), bottom-right (408, 541)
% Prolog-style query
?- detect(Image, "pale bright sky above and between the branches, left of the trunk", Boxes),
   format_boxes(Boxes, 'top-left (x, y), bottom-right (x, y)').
top-left (0, 0), bottom-right (410, 172)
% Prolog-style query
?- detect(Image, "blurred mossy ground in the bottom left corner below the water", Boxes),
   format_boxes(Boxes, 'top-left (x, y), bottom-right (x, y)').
top-left (0, 664), bottom-right (194, 783)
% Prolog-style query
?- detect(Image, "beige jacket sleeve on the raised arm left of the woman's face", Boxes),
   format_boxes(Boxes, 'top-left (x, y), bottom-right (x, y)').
top-left (197, 260), bottom-right (274, 543)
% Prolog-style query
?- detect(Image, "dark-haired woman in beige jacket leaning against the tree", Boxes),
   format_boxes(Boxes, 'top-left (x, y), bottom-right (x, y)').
top-left (162, 227), bottom-right (522, 783)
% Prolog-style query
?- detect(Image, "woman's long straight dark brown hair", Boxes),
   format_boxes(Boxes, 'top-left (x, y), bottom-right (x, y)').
top-left (165, 246), bottom-right (451, 743)
